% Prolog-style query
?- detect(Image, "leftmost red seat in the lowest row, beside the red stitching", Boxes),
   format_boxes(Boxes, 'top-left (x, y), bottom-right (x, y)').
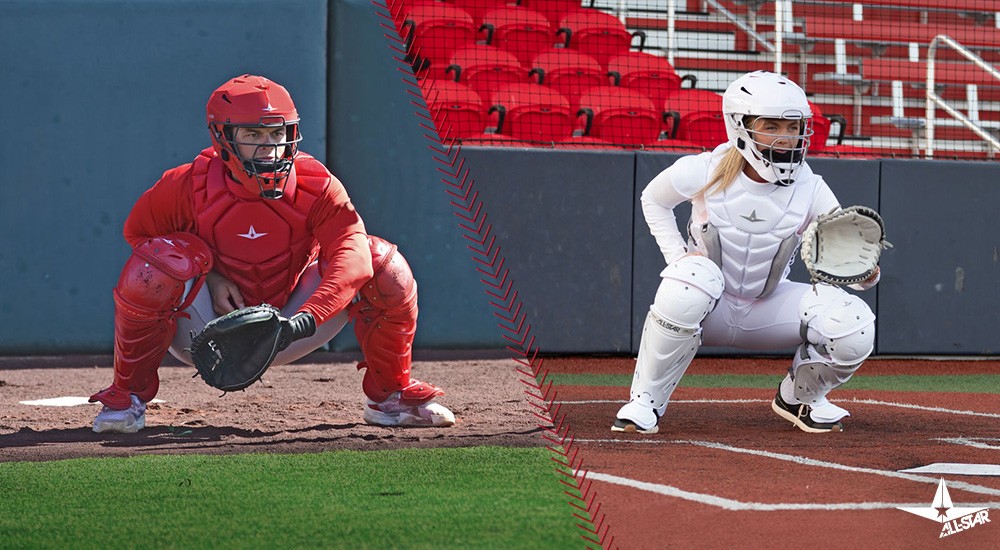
top-left (421, 80), bottom-right (489, 140)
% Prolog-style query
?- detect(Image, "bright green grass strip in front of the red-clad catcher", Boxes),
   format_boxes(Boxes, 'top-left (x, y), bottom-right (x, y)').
top-left (0, 447), bottom-right (585, 549)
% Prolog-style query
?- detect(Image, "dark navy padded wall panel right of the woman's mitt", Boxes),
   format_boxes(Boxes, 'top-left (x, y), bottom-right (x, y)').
top-left (878, 160), bottom-right (1000, 355)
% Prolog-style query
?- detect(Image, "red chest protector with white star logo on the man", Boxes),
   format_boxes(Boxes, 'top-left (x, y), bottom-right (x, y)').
top-left (192, 149), bottom-right (330, 308)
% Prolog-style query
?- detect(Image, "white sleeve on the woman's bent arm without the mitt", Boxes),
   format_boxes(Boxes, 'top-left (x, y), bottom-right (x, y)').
top-left (640, 155), bottom-right (707, 264)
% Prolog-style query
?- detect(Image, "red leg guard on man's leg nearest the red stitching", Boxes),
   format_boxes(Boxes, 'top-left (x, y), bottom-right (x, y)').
top-left (350, 236), bottom-right (444, 404)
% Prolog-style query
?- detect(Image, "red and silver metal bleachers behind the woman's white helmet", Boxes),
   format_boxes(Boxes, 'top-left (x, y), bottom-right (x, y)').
top-left (620, 0), bottom-right (1000, 159)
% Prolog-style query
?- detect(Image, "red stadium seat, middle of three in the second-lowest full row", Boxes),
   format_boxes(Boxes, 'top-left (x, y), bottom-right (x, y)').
top-left (528, 48), bottom-right (608, 111)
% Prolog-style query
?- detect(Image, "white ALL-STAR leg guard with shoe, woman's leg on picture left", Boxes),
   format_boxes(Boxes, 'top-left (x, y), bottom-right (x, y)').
top-left (611, 256), bottom-right (722, 433)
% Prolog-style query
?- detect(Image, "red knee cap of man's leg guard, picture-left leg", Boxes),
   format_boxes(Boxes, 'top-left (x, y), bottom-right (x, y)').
top-left (115, 233), bottom-right (212, 315)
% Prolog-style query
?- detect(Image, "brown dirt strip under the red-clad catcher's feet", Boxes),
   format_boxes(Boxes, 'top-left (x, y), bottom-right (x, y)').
top-left (0, 352), bottom-right (543, 461)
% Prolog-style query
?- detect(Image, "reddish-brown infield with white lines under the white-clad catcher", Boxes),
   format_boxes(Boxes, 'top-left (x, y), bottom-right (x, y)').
top-left (546, 358), bottom-right (1000, 549)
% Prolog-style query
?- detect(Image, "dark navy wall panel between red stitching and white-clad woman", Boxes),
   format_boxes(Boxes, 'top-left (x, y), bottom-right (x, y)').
top-left (463, 149), bottom-right (634, 353)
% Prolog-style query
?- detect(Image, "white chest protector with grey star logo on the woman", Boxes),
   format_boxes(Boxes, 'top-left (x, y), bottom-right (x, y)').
top-left (688, 157), bottom-right (822, 299)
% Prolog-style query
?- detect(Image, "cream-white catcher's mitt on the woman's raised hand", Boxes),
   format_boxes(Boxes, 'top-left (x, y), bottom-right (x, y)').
top-left (801, 206), bottom-right (892, 285)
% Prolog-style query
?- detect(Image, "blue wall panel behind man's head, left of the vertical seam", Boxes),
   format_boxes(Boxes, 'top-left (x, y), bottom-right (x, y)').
top-left (0, 0), bottom-right (327, 353)
